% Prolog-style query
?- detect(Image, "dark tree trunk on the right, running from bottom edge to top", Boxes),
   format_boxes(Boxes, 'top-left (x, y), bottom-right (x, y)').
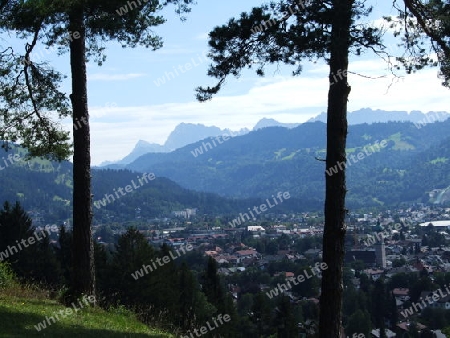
top-left (319, 0), bottom-right (354, 338)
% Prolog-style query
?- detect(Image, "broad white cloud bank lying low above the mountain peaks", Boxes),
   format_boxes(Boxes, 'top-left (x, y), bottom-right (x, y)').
top-left (78, 56), bottom-right (450, 164)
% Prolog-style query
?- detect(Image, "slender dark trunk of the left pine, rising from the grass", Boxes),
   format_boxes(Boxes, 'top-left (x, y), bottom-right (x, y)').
top-left (69, 5), bottom-right (95, 297)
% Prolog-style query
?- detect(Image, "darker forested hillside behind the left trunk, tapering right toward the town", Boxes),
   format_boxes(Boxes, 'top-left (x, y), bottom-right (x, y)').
top-left (0, 148), bottom-right (302, 222)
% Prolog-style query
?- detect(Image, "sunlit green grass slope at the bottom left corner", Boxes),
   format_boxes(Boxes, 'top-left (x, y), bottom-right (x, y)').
top-left (0, 286), bottom-right (175, 338)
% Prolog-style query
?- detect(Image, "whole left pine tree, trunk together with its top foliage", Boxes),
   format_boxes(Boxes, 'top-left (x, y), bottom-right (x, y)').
top-left (0, 0), bottom-right (192, 298)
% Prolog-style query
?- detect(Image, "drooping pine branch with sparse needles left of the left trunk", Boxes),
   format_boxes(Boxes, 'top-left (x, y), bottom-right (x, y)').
top-left (0, 25), bottom-right (71, 160)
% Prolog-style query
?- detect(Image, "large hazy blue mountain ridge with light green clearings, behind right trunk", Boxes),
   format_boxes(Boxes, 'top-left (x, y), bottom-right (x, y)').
top-left (122, 118), bottom-right (450, 209)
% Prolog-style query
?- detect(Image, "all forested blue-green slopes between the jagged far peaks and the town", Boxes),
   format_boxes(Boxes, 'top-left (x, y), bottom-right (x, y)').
top-left (0, 109), bottom-right (450, 223)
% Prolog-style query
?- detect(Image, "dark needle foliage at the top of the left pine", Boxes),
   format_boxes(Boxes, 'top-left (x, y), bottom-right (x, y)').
top-left (1, 0), bottom-right (192, 59)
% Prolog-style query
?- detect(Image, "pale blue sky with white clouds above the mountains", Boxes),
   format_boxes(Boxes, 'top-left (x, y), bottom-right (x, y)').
top-left (4, 0), bottom-right (450, 165)
